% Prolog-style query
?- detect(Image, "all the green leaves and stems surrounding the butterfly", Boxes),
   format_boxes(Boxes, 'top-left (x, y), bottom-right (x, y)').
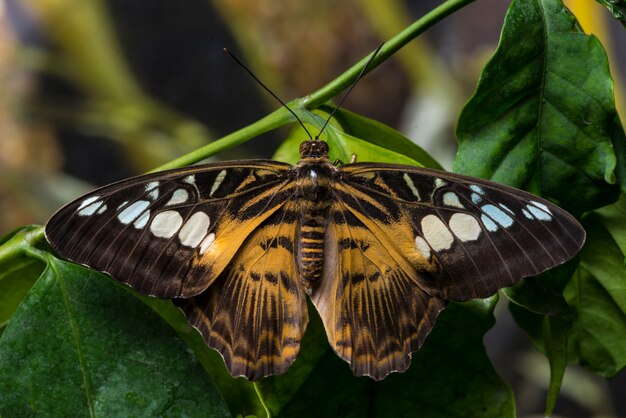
top-left (0, 0), bottom-right (626, 417)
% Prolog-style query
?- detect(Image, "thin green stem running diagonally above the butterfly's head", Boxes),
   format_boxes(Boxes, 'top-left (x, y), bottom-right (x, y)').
top-left (152, 0), bottom-right (476, 172)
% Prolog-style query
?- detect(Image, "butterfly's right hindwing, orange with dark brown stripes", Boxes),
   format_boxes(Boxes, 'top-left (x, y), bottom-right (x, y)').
top-left (311, 202), bottom-right (445, 380)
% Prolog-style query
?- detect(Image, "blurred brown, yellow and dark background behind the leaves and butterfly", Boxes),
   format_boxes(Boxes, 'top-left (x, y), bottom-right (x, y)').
top-left (0, 0), bottom-right (626, 417)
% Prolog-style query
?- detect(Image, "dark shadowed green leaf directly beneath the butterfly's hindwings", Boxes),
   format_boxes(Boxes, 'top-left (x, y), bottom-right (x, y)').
top-left (254, 297), bottom-right (514, 418)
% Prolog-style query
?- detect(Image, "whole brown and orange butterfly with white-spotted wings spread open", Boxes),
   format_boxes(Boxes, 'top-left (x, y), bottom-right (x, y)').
top-left (45, 140), bottom-right (585, 380)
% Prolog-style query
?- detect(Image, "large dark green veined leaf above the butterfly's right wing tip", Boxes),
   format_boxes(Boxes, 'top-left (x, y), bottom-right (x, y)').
top-left (455, 0), bottom-right (618, 213)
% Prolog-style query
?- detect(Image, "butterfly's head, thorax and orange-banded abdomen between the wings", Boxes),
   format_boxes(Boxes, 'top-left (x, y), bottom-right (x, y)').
top-left (294, 141), bottom-right (337, 294)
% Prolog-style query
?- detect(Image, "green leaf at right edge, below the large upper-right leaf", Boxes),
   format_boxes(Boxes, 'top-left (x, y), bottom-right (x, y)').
top-left (565, 204), bottom-right (626, 377)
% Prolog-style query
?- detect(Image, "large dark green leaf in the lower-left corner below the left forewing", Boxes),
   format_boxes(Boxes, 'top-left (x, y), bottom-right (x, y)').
top-left (0, 256), bottom-right (229, 417)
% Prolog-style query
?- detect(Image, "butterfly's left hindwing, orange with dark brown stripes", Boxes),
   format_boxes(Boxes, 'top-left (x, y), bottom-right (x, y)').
top-left (175, 202), bottom-right (308, 380)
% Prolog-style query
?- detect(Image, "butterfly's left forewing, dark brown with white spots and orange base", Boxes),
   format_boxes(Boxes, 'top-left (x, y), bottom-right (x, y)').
top-left (46, 161), bottom-right (292, 298)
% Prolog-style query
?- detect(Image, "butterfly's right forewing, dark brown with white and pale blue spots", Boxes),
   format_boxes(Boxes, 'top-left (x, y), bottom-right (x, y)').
top-left (335, 163), bottom-right (585, 301)
